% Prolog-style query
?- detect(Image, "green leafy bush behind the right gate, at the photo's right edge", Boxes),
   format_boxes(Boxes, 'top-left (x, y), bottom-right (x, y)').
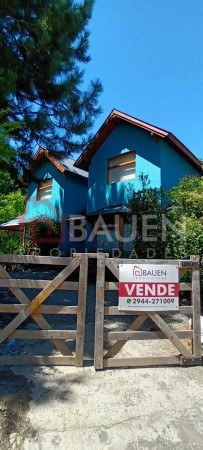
top-left (129, 175), bottom-right (203, 259)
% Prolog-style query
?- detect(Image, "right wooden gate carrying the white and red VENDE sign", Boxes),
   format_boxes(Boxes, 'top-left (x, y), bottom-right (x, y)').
top-left (95, 254), bottom-right (202, 369)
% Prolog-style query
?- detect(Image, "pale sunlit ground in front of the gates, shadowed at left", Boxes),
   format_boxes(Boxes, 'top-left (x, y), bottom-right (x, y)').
top-left (0, 367), bottom-right (203, 450)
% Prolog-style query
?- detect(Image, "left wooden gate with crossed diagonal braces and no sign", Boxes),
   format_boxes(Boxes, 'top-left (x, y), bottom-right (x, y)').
top-left (0, 254), bottom-right (88, 366)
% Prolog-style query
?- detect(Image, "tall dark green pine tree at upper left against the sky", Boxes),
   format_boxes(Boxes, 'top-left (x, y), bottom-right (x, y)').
top-left (0, 0), bottom-right (102, 166)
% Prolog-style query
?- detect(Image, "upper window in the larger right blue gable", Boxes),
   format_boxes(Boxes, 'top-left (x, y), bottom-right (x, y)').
top-left (108, 152), bottom-right (135, 184)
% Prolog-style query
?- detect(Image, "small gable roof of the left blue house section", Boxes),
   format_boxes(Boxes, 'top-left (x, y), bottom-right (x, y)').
top-left (31, 147), bottom-right (88, 178)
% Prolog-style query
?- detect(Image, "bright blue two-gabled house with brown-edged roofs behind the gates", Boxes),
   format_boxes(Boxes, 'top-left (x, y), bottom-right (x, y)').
top-left (1, 110), bottom-right (202, 255)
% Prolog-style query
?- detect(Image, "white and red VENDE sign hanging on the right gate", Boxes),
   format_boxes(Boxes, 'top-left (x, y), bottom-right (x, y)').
top-left (118, 264), bottom-right (179, 311)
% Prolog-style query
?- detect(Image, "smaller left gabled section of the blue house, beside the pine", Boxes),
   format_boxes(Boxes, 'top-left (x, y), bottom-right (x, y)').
top-left (24, 148), bottom-right (88, 250)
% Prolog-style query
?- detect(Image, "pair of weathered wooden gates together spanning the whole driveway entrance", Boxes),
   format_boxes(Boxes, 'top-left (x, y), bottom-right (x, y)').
top-left (0, 254), bottom-right (202, 369)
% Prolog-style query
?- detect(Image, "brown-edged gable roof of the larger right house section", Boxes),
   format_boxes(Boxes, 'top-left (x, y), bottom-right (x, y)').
top-left (75, 109), bottom-right (202, 173)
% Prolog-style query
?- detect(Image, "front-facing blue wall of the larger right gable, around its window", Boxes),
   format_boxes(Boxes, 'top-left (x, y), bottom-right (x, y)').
top-left (87, 124), bottom-right (161, 213)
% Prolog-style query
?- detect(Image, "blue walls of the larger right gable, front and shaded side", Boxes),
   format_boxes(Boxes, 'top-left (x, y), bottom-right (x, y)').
top-left (87, 124), bottom-right (199, 213)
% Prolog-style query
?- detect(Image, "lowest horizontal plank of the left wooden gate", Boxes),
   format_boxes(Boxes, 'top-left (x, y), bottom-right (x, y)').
top-left (0, 356), bottom-right (75, 366)
